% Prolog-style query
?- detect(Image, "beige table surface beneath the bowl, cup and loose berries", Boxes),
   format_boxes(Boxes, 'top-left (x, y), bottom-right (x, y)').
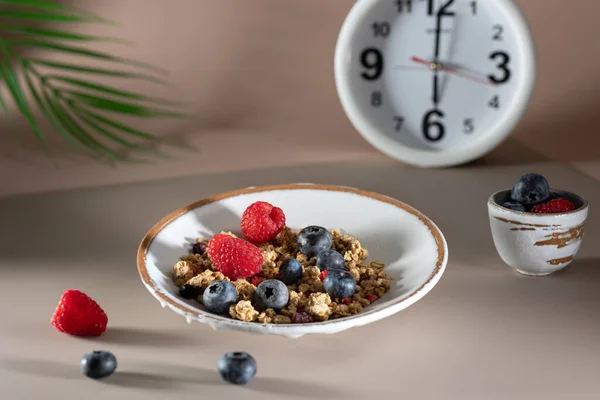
top-left (0, 157), bottom-right (600, 400)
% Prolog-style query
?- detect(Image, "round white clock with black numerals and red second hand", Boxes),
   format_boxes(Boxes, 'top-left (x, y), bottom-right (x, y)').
top-left (334, 0), bottom-right (535, 167)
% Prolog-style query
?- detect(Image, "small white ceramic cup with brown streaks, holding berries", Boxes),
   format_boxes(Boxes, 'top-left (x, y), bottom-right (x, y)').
top-left (488, 189), bottom-right (588, 276)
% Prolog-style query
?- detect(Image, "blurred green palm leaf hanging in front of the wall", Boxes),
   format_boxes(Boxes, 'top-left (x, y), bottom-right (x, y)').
top-left (0, 0), bottom-right (187, 163)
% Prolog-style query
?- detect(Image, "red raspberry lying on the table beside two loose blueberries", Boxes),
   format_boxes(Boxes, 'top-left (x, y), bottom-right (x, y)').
top-left (50, 289), bottom-right (108, 336)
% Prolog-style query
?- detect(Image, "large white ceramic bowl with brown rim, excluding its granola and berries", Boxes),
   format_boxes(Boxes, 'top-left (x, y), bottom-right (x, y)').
top-left (137, 184), bottom-right (448, 338)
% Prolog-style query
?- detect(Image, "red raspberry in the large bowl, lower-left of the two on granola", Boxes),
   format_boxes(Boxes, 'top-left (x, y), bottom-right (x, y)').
top-left (207, 233), bottom-right (264, 280)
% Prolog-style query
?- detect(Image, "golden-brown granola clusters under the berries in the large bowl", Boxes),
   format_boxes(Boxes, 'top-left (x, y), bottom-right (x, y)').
top-left (174, 227), bottom-right (392, 324)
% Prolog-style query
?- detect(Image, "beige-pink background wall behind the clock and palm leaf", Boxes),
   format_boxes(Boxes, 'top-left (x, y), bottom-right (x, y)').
top-left (0, 0), bottom-right (600, 195)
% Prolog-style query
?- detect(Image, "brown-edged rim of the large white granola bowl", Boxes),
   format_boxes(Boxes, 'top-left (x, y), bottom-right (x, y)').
top-left (137, 183), bottom-right (448, 334)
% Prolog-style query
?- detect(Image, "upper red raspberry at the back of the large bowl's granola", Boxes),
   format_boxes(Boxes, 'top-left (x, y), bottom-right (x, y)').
top-left (241, 201), bottom-right (285, 244)
